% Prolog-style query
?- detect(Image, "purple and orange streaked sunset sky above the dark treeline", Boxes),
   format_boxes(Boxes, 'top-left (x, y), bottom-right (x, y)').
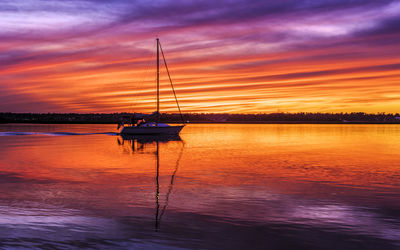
top-left (0, 0), bottom-right (400, 113)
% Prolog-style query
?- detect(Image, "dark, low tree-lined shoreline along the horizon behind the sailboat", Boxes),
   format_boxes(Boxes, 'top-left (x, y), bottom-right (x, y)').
top-left (0, 112), bottom-right (400, 124)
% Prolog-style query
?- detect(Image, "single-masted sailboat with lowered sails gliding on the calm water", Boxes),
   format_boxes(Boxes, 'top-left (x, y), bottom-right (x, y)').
top-left (121, 38), bottom-right (185, 136)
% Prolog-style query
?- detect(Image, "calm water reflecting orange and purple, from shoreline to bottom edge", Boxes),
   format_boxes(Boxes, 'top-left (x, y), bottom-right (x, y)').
top-left (0, 124), bottom-right (400, 249)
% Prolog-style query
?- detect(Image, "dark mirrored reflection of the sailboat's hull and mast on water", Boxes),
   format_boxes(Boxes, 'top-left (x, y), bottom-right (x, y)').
top-left (118, 134), bottom-right (185, 231)
